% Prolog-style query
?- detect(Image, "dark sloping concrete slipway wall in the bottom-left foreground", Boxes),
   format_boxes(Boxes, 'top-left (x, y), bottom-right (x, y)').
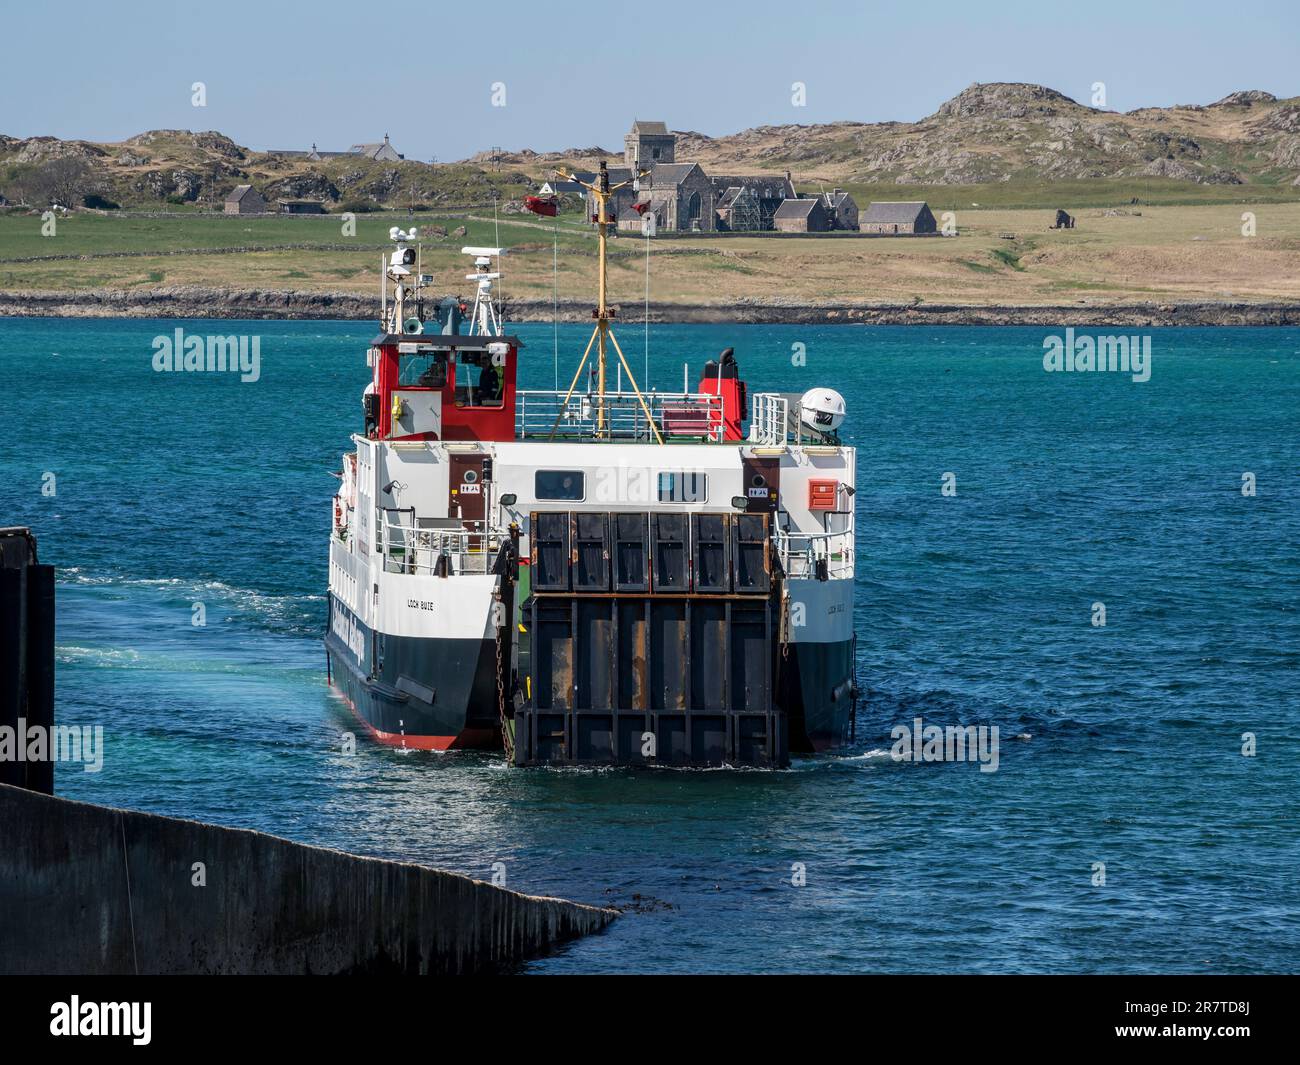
top-left (0, 785), bottom-right (618, 974)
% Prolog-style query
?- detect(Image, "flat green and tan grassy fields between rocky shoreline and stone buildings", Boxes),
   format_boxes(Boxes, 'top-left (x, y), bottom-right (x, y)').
top-left (0, 204), bottom-right (1300, 313)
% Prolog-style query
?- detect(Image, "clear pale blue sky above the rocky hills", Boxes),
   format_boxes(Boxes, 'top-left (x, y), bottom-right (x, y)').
top-left (0, 0), bottom-right (1300, 161)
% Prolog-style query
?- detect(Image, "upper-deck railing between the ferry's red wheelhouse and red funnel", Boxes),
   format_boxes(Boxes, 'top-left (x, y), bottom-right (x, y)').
top-left (515, 391), bottom-right (723, 441)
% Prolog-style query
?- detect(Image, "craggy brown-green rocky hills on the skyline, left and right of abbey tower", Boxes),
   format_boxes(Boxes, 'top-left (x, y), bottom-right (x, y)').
top-left (0, 82), bottom-right (1300, 208)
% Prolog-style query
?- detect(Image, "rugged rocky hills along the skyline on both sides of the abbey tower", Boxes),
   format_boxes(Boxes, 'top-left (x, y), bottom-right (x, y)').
top-left (0, 83), bottom-right (1300, 218)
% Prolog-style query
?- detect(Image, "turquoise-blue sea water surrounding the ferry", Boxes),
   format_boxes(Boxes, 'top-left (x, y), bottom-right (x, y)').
top-left (0, 320), bottom-right (1300, 971)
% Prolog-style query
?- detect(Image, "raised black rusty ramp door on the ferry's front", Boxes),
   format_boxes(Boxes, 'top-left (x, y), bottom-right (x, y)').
top-left (515, 511), bottom-right (789, 766)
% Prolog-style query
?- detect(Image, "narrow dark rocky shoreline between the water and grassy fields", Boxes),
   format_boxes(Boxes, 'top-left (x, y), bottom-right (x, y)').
top-left (0, 287), bottom-right (1300, 328)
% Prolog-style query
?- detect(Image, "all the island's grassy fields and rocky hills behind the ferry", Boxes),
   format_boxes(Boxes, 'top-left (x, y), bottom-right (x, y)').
top-left (0, 83), bottom-right (1300, 306)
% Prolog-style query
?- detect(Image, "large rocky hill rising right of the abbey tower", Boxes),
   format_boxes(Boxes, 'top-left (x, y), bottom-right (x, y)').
top-left (538, 82), bottom-right (1300, 191)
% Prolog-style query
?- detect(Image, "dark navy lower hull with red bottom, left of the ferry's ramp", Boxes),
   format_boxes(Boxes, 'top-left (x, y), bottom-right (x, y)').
top-left (325, 596), bottom-right (501, 750)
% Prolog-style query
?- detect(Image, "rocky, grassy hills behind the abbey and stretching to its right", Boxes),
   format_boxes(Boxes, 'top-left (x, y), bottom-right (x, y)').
top-left (480, 83), bottom-right (1300, 209)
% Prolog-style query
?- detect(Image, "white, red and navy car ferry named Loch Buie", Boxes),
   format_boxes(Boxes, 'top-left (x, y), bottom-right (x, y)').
top-left (325, 164), bottom-right (858, 767)
